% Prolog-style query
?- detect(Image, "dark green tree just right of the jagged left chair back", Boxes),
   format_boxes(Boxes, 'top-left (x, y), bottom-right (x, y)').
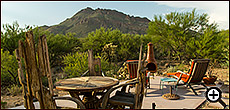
top-left (33, 27), bottom-right (82, 68)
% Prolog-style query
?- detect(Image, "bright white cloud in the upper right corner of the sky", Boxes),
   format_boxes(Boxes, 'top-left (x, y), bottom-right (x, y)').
top-left (157, 1), bottom-right (229, 29)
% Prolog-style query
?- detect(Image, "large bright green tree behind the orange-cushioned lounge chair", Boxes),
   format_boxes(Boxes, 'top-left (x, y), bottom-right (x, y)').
top-left (147, 9), bottom-right (226, 64)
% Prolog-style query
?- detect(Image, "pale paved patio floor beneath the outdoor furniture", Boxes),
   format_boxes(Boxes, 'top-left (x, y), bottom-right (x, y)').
top-left (10, 76), bottom-right (229, 109)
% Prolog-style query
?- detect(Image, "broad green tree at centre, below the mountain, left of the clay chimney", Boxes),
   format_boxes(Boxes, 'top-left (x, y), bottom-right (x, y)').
top-left (83, 27), bottom-right (147, 61)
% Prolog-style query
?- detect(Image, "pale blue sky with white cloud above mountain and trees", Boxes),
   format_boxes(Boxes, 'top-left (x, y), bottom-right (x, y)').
top-left (1, 1), bottom-right (229, 31)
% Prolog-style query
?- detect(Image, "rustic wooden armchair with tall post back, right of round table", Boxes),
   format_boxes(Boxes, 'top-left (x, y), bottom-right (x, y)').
top-left (102, 45), bottom-right (145, 109)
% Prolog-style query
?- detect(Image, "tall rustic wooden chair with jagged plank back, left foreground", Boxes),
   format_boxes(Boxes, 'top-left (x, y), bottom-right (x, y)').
top-left (15, 31), bottom-right (85, 109)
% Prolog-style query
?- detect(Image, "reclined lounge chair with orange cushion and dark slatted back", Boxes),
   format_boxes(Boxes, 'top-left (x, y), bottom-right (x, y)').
top-left (167, 59), bottom-right (210, 95)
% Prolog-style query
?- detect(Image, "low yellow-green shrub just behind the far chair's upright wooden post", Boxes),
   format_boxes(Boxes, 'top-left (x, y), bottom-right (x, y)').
top-left (63, 52), bottom-right (112, 77)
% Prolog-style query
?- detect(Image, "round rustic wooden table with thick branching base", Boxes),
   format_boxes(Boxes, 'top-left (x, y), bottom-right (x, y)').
top-left (55, 76), bottom-right (119, 109)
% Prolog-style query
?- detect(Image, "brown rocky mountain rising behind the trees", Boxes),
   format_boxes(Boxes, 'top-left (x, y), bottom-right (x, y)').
top-left (42, 7), bottom-right (150, 37)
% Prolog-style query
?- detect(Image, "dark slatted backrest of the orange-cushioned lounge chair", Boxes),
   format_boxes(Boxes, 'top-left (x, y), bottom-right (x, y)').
top-left (187, 59), bottom-right (210, 83)
